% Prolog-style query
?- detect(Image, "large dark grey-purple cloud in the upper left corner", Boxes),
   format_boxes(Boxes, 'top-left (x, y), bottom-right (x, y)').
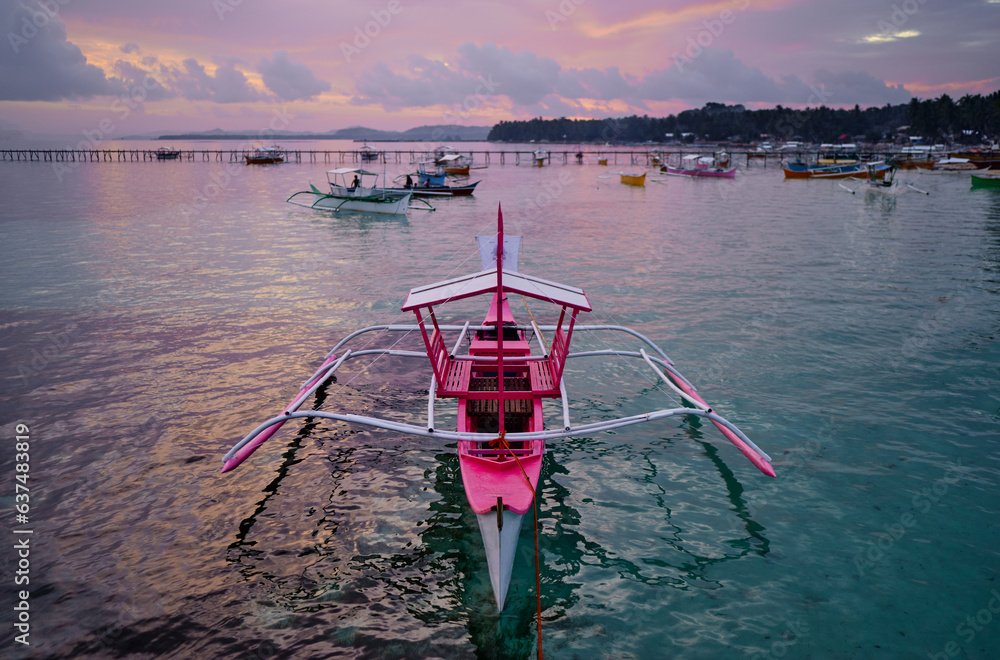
top-left (0, 0), bottom-right (121, 101)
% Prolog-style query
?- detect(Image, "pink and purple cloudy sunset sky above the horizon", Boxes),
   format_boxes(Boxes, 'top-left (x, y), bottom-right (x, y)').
top-left (0, 0), bottom-right (1000, 138)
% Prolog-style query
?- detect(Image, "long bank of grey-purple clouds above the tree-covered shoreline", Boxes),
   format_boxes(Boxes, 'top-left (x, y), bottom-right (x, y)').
top-left (353, 43), bottom-right (910, 111)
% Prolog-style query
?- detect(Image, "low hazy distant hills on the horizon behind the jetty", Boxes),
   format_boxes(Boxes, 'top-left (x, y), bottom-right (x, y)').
top-left (158, 124), bottom-right (493, 142)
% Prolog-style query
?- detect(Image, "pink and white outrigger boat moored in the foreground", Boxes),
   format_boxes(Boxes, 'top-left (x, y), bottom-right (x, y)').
top-left (222, 211), bottom-right (775, 611)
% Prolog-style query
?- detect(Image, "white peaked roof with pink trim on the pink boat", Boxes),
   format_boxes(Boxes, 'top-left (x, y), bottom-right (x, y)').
top-left (402, 268), bottom-right (591, 312)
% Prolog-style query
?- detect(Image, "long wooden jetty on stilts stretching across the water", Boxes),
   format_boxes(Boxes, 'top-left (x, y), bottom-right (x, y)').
top-left (0, 145), bottom-right (940, 166)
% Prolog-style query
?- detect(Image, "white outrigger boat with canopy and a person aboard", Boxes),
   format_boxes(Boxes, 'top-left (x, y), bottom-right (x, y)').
top-left (285, 167), bottom-right (433, 215)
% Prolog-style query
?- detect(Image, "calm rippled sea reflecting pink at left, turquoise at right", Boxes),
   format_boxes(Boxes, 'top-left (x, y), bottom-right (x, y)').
top-left (0, 138), bottom-right (1000, 659)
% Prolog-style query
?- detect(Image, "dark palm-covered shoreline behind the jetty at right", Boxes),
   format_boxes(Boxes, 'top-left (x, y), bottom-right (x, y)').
top-left (487, 91), bottom-right (1000, 144)
